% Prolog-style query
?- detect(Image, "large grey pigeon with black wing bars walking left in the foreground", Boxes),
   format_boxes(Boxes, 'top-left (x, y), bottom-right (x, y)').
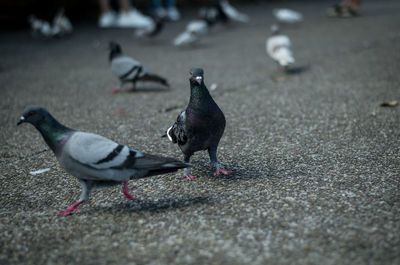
top-left (17, 106), bottom-right (190, 215)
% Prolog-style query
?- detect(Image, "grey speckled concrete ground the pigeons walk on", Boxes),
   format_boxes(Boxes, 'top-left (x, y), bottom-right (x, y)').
top-left (0, 0), bottom-right (400, 265)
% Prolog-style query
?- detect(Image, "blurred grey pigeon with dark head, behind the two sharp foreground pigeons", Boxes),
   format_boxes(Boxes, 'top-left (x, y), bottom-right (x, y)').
top-left (110, 42), bottom-right (169, 93)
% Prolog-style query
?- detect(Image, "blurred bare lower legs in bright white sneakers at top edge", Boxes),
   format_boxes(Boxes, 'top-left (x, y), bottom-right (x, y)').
top-left (98, 0), bottom-right (153, 28)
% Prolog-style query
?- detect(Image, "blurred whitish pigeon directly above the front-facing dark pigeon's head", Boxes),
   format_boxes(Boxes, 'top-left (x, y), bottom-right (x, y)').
top-left (173, 19), bottom-right (208, 46)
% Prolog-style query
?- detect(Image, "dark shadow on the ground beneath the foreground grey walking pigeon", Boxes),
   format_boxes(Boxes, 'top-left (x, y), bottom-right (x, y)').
top-left (89, 196), bottom-right (211, 213)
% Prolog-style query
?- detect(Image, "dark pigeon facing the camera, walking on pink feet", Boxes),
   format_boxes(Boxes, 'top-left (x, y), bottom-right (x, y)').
top-left (163, 68), bottom-right (230, 180)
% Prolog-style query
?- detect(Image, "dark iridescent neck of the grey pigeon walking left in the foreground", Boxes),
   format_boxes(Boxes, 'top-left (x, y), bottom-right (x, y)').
top-left (35, 114), bottom-right (73, 156)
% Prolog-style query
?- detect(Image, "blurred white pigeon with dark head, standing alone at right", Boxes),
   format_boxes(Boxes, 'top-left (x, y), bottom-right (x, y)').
top-left (265, 24), bottom-right (295, 70)
